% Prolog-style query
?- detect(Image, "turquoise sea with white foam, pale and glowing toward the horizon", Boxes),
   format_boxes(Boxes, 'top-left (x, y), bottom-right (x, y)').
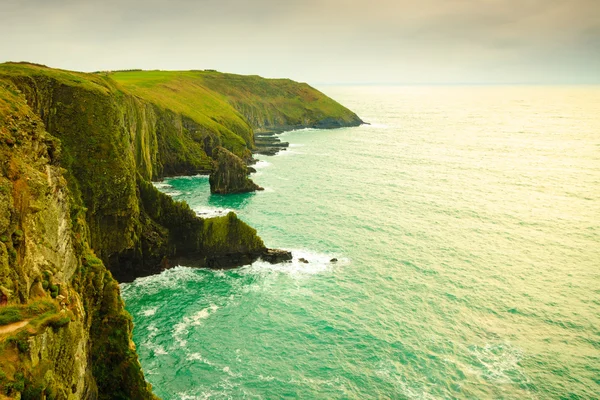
top-left (122, 87), bottom-right (600, 399)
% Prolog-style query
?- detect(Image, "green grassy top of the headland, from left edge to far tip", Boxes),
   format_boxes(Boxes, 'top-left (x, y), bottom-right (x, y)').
top-left (0, 63), bottom-right (362, 158)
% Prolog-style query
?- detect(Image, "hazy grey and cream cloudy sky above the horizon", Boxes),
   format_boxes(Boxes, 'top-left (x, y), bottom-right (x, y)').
top-left (0, 0), bottom-right (600, 84)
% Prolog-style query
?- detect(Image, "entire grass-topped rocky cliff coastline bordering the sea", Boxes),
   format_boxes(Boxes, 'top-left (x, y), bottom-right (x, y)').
top-left (0, 63), bottom-right (360, 399)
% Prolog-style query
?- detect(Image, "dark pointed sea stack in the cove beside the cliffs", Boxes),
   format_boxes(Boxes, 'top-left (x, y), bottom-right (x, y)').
top-left (209, 146), bottom-right (263, 194)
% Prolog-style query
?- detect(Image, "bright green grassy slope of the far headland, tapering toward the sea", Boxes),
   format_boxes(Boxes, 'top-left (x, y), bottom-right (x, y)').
top-left (110, 71), bottom-right (360, 133)
